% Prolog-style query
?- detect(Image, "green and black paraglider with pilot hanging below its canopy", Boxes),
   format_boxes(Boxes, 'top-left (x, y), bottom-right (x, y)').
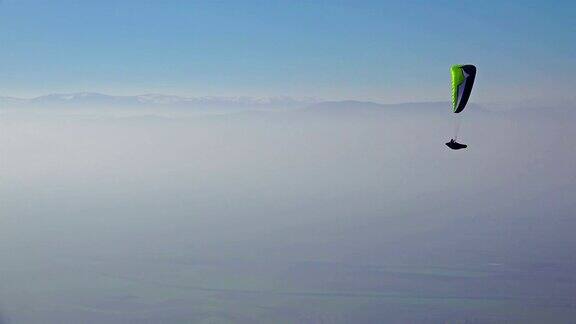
top-left (446, 64), bottom-right (476, 150)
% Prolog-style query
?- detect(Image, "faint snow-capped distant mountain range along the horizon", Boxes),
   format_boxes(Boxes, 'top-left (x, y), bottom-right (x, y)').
top-left (0, 92), bottom-right (576, 117)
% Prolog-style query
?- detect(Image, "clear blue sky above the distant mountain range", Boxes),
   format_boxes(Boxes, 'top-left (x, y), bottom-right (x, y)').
top-left (0, 0), bottom-right (576, 102)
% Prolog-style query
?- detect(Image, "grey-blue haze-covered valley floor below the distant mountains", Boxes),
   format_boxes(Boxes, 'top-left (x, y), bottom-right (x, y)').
top-left (0, 105), bottom-right (576, 323)
